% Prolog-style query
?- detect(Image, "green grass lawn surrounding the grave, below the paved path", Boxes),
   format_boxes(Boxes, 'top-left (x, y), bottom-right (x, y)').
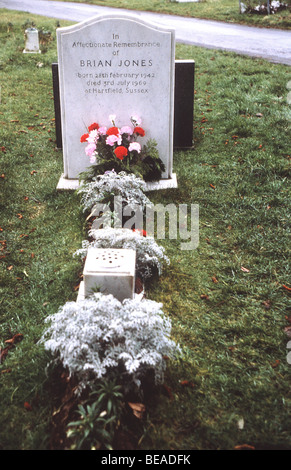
top-left (0, 9), bottom-right (291, 450)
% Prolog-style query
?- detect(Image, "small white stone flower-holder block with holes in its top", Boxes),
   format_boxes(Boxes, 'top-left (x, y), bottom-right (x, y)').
top-left (83, 247), bottom-right (136, 301)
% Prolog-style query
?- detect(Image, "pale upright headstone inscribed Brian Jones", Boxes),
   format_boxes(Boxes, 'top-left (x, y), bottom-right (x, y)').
top-left (57, 14), bottom-right (175, 185)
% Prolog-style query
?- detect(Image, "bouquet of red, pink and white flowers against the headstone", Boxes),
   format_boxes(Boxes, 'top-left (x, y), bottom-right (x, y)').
top-left (80, 115), bottom-right (165, 181)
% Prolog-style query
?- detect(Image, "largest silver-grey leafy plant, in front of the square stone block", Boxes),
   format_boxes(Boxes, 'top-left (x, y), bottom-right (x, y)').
top-left (41, 293), bottom-right (179, 391)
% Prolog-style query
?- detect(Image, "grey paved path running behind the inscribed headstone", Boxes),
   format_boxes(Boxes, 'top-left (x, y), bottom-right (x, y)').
top-left (0, 0), bottom-right (291, 65)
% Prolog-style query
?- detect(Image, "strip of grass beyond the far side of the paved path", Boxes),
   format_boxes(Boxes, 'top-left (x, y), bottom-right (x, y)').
top-left (53, 0), bottom-right (291, 29)
